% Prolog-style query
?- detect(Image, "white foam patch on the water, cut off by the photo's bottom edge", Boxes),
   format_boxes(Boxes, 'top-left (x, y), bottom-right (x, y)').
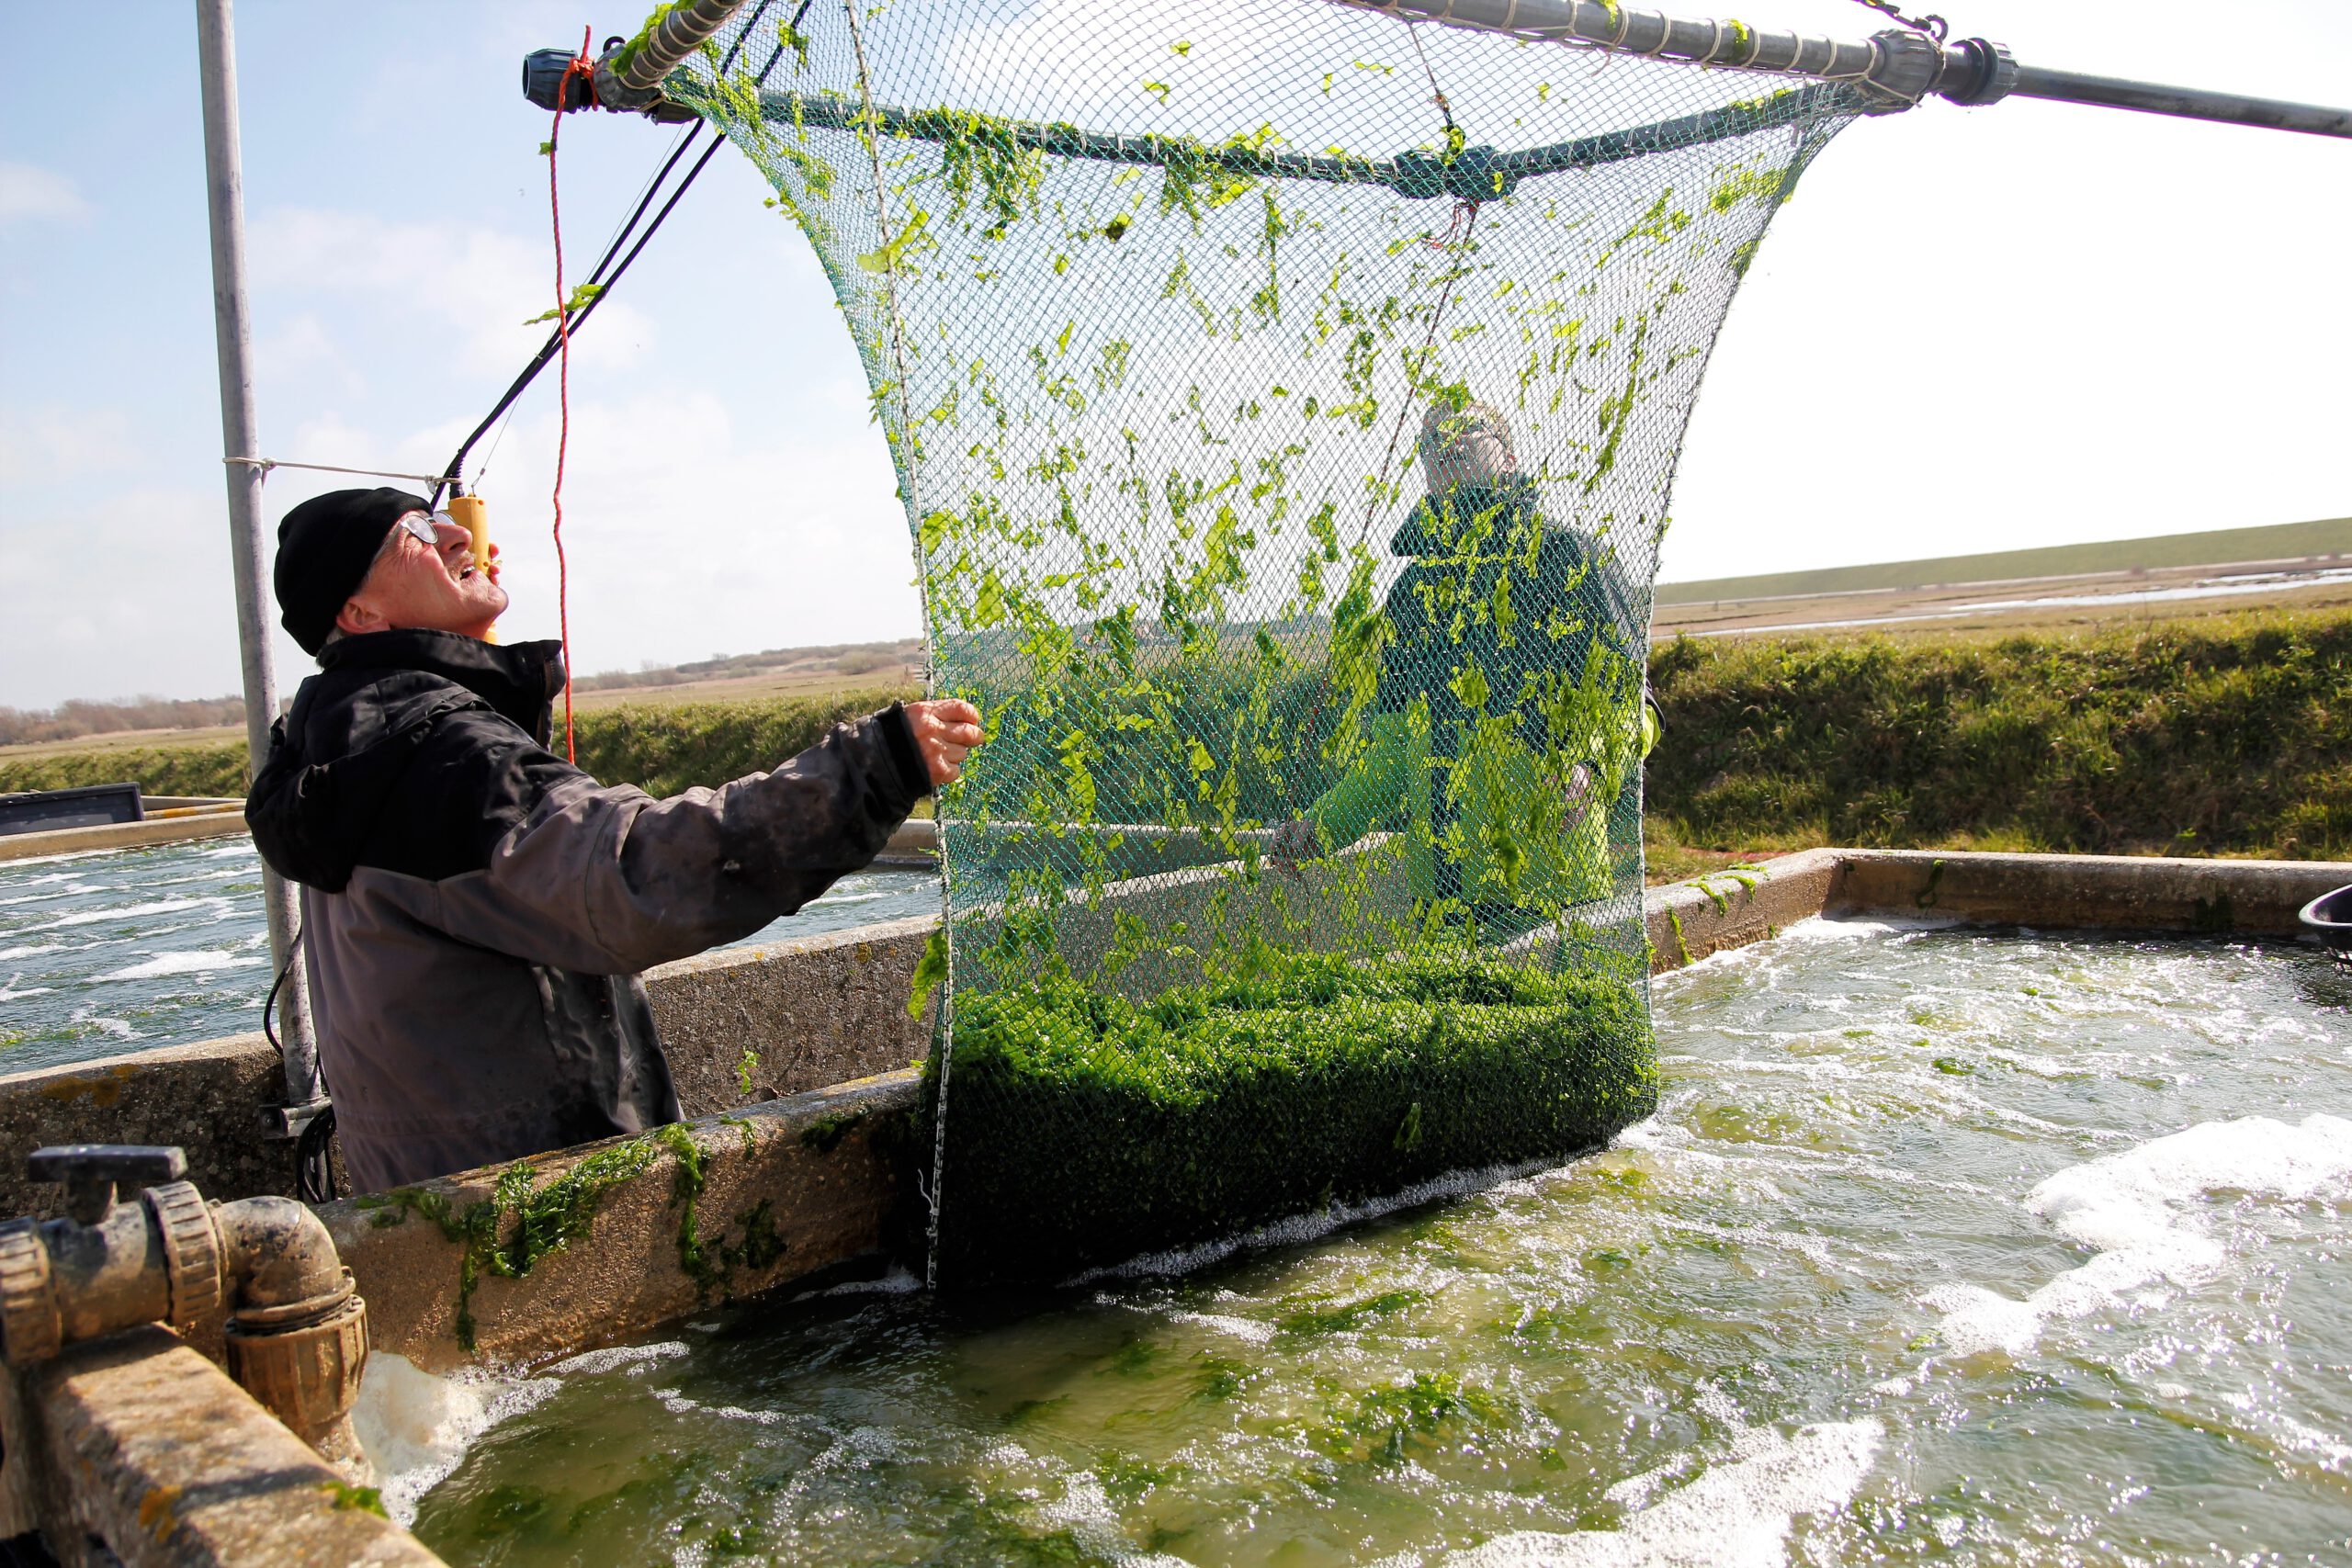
top-left (1446, 1420), bottom-right (1886, 1568)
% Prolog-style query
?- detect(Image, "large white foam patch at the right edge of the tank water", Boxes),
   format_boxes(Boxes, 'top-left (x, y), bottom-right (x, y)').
top-left (1928, 1114), bottom-right (2352, 1357)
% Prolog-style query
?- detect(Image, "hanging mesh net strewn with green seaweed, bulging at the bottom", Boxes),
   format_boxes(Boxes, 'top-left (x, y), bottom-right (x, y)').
top-left (671, 0), bottom-right (1858, 1283)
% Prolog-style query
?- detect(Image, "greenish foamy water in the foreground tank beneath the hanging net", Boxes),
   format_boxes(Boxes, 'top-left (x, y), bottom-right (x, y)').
top-left (416, 921), bottom-right (2352, 1568)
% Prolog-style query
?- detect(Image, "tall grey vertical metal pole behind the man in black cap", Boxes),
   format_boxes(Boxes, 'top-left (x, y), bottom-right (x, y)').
top-left (195, 0), bottom-right (318, 1114)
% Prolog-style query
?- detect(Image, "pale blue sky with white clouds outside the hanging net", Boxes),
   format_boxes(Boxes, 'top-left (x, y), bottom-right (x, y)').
top-left (0, 0), bottom-right (2352, 707)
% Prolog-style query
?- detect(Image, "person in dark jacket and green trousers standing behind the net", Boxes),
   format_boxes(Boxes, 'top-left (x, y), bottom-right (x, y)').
top-left (1272, 402), bottom-right (1646, 941)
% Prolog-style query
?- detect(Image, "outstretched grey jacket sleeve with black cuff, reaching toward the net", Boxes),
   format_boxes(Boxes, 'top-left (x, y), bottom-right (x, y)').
top-left (367, 705), bottom-right (929, 974)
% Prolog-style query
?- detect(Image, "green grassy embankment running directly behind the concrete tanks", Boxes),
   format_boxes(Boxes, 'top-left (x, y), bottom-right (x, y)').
top-left (0, 611), bottom-right (2352, 874)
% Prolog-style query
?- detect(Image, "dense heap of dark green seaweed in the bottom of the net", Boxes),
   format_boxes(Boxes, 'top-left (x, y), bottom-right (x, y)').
top-left (938, 954), bottom-right (1656, 1286)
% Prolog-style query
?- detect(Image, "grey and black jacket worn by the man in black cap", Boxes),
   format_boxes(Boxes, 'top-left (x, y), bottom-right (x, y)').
top-left (244, 630), bottom-right (929, 1192)
